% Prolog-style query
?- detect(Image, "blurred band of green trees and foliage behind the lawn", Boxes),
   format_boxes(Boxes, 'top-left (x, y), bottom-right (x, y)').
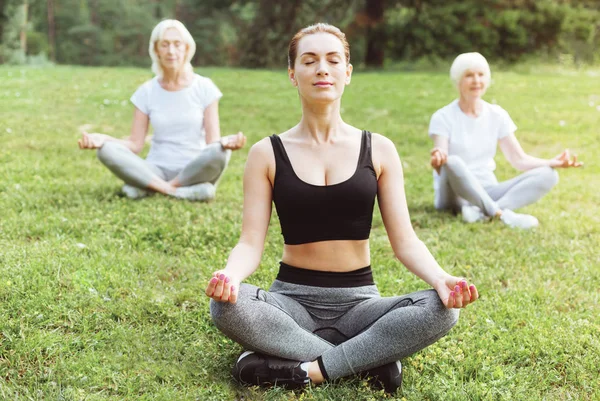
top-left (0, 0), bottom-right (600, 68)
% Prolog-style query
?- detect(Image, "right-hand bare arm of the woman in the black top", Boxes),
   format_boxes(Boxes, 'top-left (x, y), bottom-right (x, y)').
top-left (373, 134), bottom-right (478, 308)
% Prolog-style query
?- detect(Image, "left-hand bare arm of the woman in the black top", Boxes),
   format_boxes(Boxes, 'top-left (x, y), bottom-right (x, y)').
top-left (206, 138), bottom-right (275, 303)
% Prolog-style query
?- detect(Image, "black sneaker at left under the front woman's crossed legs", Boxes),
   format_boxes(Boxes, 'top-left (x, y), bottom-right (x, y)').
top-left (231, 351), bottom-right (310, 389)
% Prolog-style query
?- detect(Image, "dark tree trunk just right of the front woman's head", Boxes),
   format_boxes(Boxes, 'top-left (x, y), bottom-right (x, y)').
top-left (365, 0), bottom-right (387, 68)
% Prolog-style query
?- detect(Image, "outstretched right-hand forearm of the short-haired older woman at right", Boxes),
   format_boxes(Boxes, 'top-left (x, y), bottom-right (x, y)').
top-left (498, 133), bottom-right (583, 171)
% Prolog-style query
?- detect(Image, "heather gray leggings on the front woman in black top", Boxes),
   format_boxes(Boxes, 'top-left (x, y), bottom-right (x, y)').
top-left (210, 280), bottom-right (459, 380)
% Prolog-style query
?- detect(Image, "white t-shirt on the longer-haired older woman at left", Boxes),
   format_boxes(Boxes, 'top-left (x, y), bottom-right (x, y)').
top-left (131, 74), bottom-right (223, 170)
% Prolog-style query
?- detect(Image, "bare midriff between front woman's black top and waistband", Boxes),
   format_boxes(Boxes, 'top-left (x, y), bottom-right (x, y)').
top-left (281, 239), bottom-right (371, 272)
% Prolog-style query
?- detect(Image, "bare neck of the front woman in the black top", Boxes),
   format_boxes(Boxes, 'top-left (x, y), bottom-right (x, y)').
top-left (298, 99), bottom-right (346, 143)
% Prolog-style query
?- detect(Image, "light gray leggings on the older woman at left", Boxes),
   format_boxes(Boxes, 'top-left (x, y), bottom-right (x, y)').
top-left (98, 141), bottom-right (231, 189)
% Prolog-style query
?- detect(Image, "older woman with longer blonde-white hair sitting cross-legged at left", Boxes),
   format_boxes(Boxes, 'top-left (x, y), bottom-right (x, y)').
top-left (79, 20), bottom-right (246, 201)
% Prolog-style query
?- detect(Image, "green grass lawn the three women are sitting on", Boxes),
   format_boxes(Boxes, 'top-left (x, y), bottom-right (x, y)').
top-left (0, 66), bottom-right (600, 401)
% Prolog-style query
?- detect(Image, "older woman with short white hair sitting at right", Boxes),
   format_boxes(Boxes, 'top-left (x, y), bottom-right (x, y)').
top-left (429, 53), bottom-right (582, 229)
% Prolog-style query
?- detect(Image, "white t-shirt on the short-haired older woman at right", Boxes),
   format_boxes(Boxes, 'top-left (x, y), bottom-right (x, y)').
top-left (429, 99), bottom-right (517, 192)
